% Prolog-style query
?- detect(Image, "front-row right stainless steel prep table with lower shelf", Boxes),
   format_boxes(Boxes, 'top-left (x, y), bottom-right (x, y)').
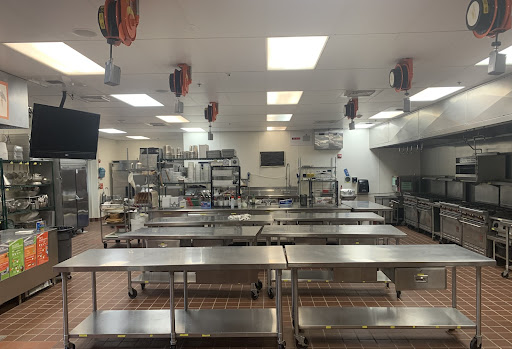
top-left (285, 245), bottom-right (495, 349)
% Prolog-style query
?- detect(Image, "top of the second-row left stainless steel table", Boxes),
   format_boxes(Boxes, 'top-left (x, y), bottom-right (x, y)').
top-left (122, 226), bottom-right (262, 240)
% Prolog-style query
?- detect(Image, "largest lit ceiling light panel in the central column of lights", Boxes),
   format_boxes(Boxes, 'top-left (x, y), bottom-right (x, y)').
top-left (267, 36), bottom-right (329, 70)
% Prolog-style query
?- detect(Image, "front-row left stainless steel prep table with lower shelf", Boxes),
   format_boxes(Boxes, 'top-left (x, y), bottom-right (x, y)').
top-left (54, 246), bottom-right (286, 349)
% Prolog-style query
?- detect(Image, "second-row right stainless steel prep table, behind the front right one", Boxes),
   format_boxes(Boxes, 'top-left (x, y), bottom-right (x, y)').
top-left (260, 225), bottom-right (407, 298)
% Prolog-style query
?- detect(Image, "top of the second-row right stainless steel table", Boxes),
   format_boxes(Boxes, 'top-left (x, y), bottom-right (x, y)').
top-left (260, 224), bottom-right (407, 238)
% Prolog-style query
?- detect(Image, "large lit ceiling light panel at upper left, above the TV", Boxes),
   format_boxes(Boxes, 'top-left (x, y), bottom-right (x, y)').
top-left (4, 42), bottom-right (105, 75)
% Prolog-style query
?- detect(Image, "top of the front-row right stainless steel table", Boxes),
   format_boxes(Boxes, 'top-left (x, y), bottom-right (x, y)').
top-left (286, 245), bottom-right (496, 268)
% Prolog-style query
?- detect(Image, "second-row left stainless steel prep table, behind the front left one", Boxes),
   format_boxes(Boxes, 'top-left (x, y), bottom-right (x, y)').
top-left (123, 227), bottom-right (262, 299)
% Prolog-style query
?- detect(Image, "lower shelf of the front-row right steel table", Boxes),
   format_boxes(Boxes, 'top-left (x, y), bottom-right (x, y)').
top-left (299, 307), bottom-right (476, 330)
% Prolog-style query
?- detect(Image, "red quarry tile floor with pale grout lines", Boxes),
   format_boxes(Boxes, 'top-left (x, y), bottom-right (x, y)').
top-left (0, 223), bottom-right (512, 349)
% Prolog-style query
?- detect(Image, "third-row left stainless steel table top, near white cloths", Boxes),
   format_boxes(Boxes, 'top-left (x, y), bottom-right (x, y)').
top-left (145, 215), bottom-right (273, 227)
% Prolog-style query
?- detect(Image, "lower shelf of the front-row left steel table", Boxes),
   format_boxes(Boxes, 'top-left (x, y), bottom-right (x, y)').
top-left (70, 308), bottom-right (277, 338)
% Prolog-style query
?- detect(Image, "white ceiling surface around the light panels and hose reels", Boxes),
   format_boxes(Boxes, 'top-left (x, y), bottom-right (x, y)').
top-left (0, 0), bottom-right (512, 139)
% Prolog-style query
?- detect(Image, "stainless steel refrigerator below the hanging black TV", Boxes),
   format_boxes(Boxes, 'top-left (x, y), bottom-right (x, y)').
top-left (54, 159), bottom-right (89, 229)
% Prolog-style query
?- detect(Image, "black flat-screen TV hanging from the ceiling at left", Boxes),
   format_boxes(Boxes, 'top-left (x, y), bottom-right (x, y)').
top-left (30, 103), bottom-right (100, 159)
